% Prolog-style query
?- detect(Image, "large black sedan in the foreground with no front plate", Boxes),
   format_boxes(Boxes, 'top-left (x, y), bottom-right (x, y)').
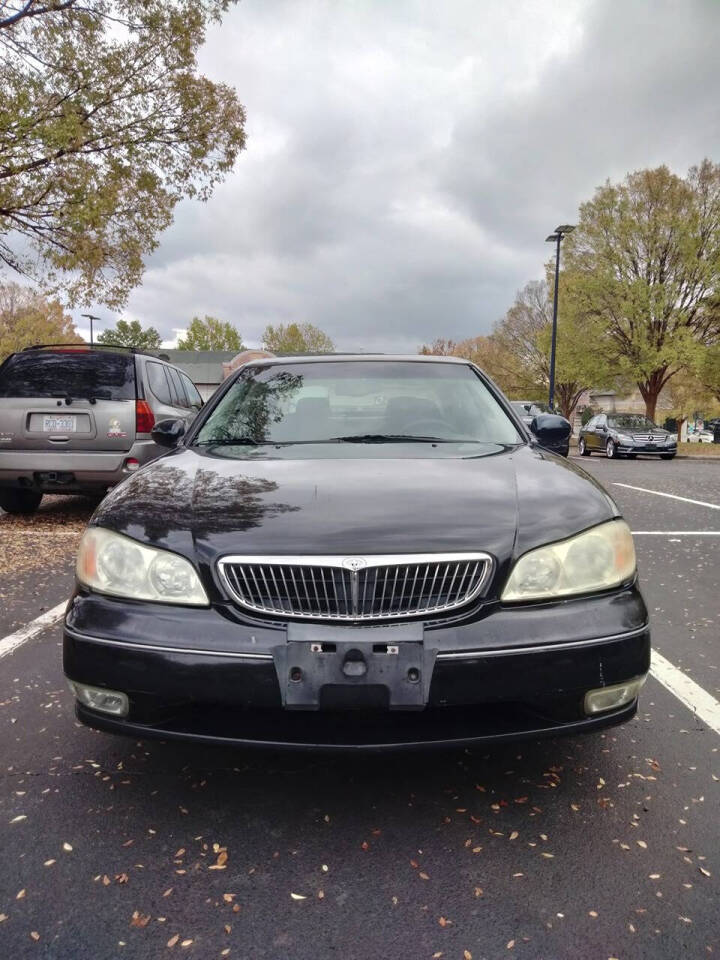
top-left (64, 356), bottom-right (650, 749)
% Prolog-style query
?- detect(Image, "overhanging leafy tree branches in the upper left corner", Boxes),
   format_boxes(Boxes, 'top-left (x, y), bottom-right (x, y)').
top-left (0, 0), bottom-right (245, 308)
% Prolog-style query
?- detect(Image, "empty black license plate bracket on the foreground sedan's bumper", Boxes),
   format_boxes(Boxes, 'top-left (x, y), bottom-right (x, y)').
top-left (273, 624), bottom-right (437, 710)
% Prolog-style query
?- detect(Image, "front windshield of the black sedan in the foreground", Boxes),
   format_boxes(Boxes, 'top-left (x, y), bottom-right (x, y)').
top-left (195, 361), bottom-right (521, 444)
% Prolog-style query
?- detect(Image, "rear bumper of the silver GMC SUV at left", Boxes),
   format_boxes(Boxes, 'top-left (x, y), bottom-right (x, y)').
top-left (0, 440), bottom-right (159, 493)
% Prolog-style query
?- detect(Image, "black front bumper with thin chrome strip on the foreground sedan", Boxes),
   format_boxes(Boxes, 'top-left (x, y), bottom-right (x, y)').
top-left (64, 587), bottom-right (650, 749)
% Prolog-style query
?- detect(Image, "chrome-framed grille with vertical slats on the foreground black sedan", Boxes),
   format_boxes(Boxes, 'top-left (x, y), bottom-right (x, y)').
top-left (218, 553), bottom-right (493, 621)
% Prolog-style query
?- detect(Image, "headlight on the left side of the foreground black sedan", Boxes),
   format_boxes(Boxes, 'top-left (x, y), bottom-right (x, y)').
top-left (76, 527), bottom-right (209, 607)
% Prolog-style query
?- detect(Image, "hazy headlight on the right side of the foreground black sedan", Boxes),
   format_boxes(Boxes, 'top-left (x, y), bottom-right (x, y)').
top-left (501, 520), bottom-right (635, 601)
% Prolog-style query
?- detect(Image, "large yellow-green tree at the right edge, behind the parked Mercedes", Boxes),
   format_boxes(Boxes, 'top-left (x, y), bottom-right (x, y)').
top-left (565, 160), bottom-right (720, 419)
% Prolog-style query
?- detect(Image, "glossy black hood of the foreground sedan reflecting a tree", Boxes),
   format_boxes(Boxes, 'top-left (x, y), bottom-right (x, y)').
top-left (92, 446), bottom-right (617, 584)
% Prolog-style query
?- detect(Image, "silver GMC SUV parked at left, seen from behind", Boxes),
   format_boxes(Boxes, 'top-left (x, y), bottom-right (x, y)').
top-left (0, 344), bottom-right (203, 513)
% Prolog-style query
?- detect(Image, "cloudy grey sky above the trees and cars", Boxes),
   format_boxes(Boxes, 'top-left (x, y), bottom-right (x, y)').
top-left (78, 0), bottom-right (720, 352)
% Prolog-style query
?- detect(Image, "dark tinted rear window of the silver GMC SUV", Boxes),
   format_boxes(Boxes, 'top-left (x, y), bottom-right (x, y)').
top-left (0, 350), bottom-right (135, 400)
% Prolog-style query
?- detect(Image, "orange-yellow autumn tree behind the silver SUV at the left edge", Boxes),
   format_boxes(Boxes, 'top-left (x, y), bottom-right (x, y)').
top-left (0, 283), bottom-right (82, 362)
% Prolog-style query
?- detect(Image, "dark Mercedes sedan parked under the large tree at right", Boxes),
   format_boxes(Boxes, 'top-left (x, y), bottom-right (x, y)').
top-left (578, 413), bottom-right (677, 460)
